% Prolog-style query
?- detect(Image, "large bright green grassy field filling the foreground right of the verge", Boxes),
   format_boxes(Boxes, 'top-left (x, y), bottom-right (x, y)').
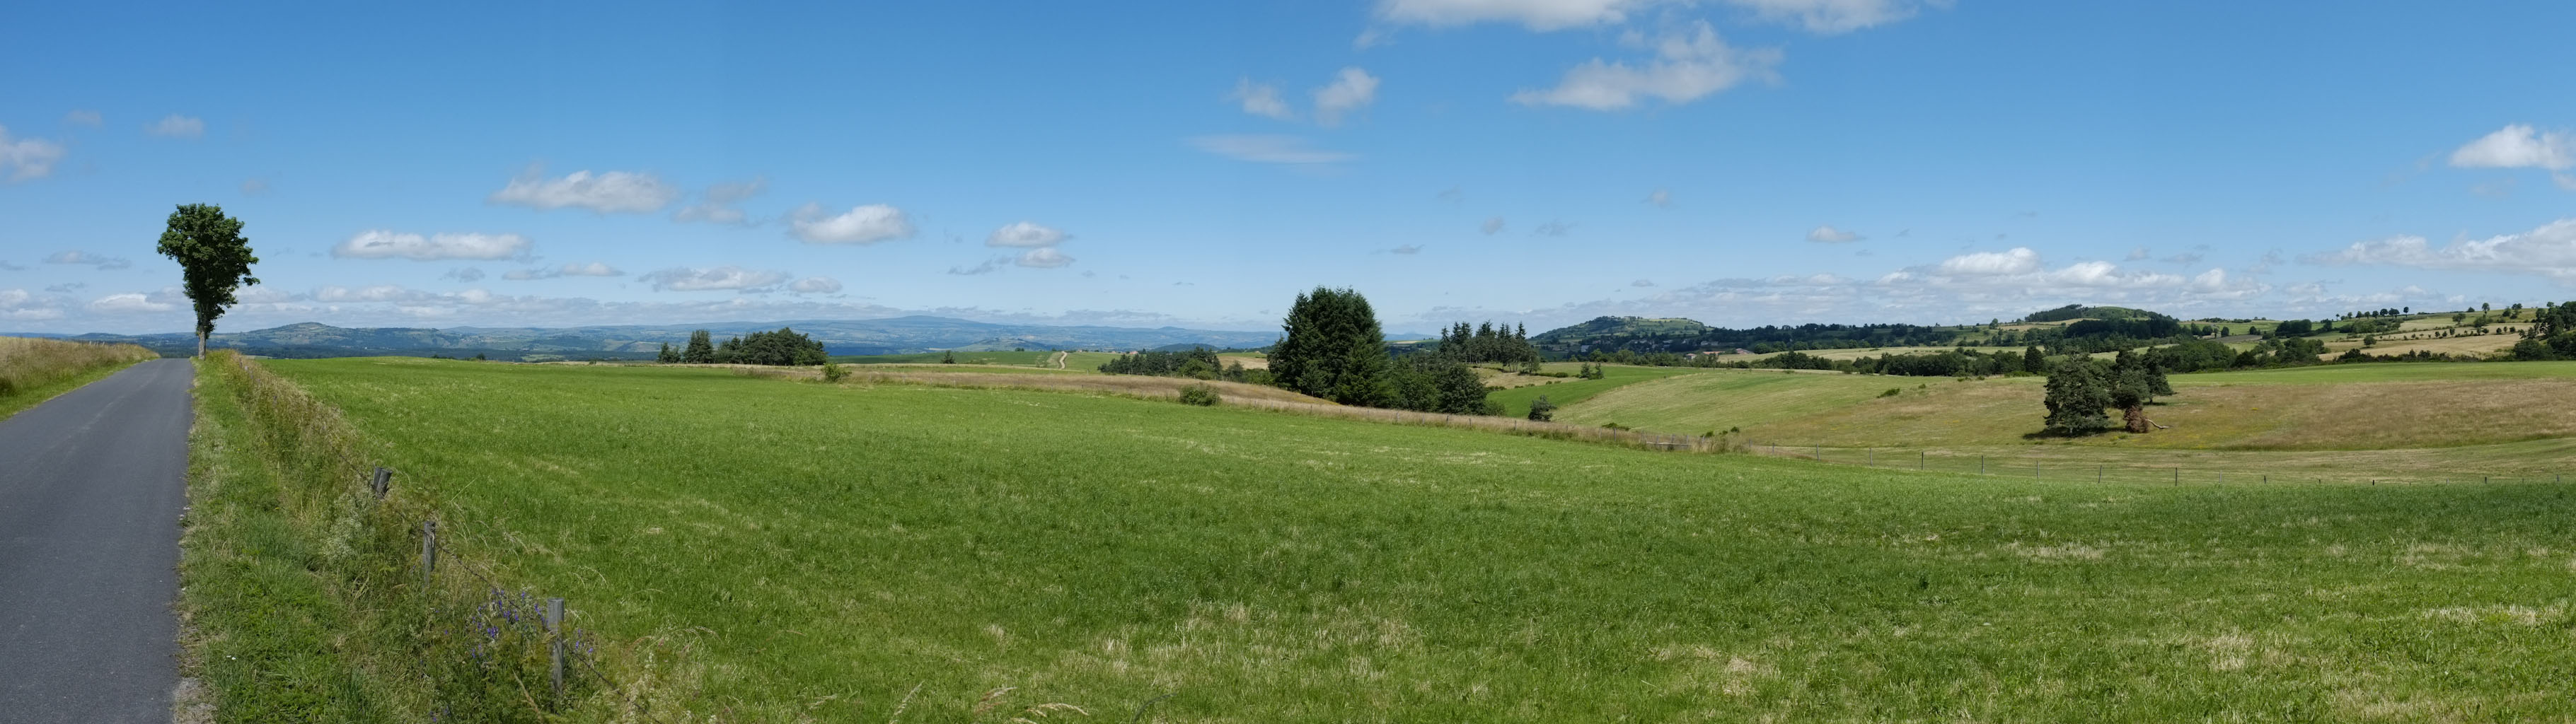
top-left (270, 358), bottom-right (2576, 721)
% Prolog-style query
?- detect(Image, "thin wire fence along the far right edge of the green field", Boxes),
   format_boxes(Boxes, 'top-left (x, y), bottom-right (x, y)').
top-left (1747, 443), bottom-right (2565, 484)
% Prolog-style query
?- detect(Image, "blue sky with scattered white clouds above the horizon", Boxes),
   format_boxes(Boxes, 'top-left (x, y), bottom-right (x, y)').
top-left (0, 0), bottom-right (2576, 332)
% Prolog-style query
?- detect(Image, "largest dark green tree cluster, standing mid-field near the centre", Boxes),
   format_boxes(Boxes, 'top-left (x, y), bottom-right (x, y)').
top-left (1270, 286), bottom-right (1499, 415)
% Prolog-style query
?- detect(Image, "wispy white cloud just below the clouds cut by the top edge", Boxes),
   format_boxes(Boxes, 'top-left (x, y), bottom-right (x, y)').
top-left (1512, 23), bottom-right (1780, 111)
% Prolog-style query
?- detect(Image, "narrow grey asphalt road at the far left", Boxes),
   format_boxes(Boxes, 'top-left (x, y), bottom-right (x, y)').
top-left (0, 361), bottom-right (190, 724)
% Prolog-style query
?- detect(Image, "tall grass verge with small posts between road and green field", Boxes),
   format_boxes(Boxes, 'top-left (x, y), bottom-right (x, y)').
top-left (183, 351), bottom-right (675, 721)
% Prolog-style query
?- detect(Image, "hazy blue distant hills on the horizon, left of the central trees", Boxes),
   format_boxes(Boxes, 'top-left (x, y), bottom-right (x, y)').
top-left (55, 317), bottom-right (1308, 361)
